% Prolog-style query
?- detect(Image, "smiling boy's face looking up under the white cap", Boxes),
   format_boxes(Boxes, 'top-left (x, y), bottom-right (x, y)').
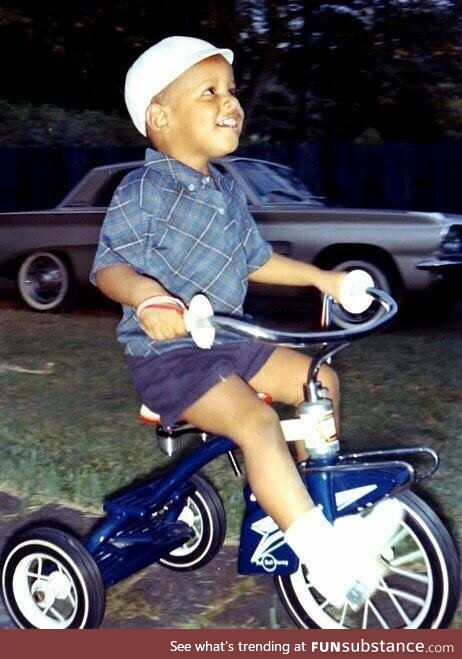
top-left (152, 55), bottom-right (244, 174)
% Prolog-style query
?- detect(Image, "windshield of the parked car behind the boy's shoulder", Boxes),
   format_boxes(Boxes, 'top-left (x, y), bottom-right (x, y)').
top-left (234, 159), bottom-right (317, 203)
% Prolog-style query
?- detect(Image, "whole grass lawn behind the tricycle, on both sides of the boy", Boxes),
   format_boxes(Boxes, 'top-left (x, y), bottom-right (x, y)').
top-left (0, 302), bottom-right (462, 624)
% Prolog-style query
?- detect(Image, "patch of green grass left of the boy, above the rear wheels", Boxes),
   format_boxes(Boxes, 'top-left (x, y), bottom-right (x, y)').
top-left (0, 310), bottom-right (237, 520)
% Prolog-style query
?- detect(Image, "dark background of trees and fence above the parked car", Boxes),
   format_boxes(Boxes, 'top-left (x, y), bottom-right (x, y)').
top-left (0, 0), bottom-right (462, 213)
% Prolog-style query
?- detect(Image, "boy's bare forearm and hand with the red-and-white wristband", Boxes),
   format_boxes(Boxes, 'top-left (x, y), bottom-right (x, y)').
top-left (95, 264), bottom-right (186, 341)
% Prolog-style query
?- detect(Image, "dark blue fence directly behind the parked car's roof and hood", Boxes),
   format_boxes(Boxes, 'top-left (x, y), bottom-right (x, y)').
top-left (0, 143), bottom-right (462, 213)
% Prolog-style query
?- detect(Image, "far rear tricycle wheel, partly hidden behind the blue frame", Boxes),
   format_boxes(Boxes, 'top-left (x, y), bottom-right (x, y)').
top-left (159, 475), bottom-right (226, 571)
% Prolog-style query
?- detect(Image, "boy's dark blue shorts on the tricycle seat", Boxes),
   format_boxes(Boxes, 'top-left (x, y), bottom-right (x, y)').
top-left (128, 341), bottom-right (275, 426)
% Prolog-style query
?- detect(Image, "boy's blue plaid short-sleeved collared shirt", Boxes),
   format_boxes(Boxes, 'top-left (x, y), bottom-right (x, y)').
top-left (90, 149), bottom-right (272, 357)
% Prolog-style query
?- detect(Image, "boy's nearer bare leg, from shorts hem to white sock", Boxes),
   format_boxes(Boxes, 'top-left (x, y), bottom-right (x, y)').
top-left (183, 375), bottom-right (313, 531)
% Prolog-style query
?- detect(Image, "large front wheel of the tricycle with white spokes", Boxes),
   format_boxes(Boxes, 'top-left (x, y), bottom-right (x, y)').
top-left (275, 492), bottom-right (460, 629)
